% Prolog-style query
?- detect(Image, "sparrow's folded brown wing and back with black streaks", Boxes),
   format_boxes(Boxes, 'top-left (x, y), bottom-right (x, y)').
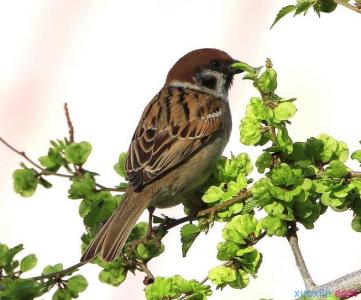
top-left (125, 87), bottom-right (226, 190)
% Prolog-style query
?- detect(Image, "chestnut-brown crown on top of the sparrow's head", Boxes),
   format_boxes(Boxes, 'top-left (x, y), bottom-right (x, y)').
top-left (165, 48), bottom-right (234, 85)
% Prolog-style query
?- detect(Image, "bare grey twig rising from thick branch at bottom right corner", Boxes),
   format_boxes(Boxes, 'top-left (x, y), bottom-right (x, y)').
top-left (287, 224), bottom-right (316, 290)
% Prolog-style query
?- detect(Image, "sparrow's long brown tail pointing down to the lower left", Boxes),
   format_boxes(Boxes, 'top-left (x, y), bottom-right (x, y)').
top-left (81, 191), bottom-right (149, 262)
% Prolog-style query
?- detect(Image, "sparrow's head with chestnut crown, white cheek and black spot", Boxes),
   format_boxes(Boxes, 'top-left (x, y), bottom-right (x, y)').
top-left (165, 48), bottom-right (241, 98)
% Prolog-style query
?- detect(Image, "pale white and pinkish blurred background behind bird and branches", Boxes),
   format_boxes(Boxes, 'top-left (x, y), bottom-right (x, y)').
top-left (0, 0), bottom-right (361, 300)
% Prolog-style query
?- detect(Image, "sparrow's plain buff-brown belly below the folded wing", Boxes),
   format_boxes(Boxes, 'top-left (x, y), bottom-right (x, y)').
top-left (150, 135), bottom-right (227, 208)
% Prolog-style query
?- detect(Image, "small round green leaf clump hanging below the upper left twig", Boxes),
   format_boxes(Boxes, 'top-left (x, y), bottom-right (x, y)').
top-left (13, 169), bottom-right (38, 197)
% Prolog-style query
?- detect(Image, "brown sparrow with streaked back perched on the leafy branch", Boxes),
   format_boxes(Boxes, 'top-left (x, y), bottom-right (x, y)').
top-left (81, 48), bottom-right (242, 262)
